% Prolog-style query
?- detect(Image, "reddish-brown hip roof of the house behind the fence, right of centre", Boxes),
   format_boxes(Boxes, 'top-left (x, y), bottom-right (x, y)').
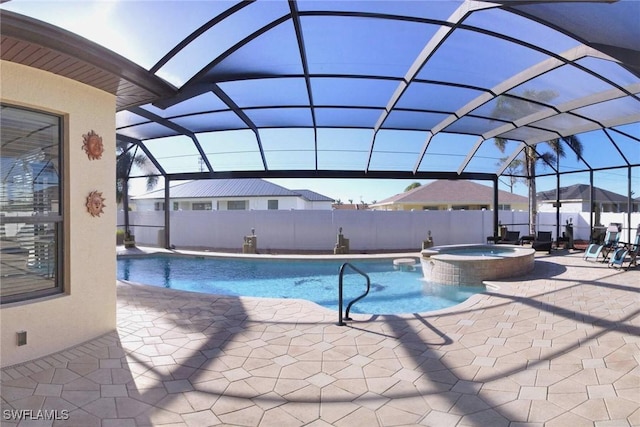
top-left (372, 180), bottom-right (528, 206)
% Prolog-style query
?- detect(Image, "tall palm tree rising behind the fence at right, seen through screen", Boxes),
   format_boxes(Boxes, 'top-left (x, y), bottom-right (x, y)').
top-left (493, 90), bottom-right (582, 235)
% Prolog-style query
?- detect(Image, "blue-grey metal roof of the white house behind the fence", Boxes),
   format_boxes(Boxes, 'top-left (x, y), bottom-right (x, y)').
top-left (133, 178), bottom-right (333, 202)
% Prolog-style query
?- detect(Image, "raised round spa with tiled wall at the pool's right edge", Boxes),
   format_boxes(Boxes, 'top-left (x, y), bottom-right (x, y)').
top-left (421, 245), bottom-right (536, 286)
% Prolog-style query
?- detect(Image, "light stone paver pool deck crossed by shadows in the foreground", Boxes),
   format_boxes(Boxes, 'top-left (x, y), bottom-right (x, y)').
top-left (0, 251), bottom-right (640, 427)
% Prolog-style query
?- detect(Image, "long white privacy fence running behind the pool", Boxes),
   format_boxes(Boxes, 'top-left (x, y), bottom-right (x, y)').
top-left (118, 210), bottom-right (640, 252)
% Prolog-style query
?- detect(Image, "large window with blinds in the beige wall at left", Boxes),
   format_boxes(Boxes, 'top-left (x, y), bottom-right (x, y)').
top-left (0, 104), bottom-right (64, 304)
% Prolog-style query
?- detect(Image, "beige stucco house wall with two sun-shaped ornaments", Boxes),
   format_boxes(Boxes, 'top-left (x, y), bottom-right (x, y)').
top-left (0, 61), bottom-right (116, 367)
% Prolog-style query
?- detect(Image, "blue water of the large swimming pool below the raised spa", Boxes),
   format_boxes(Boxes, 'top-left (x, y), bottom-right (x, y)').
top-left (118, 255), bottom-right (484, 314)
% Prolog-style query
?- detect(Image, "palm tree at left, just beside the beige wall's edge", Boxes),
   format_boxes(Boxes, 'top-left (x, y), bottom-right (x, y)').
top-left (116, 141), bottom-right (158, 235)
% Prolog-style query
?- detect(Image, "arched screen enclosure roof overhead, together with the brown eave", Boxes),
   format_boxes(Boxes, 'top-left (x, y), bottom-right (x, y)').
top-left (1, 0), bottom-right (640, 184)
